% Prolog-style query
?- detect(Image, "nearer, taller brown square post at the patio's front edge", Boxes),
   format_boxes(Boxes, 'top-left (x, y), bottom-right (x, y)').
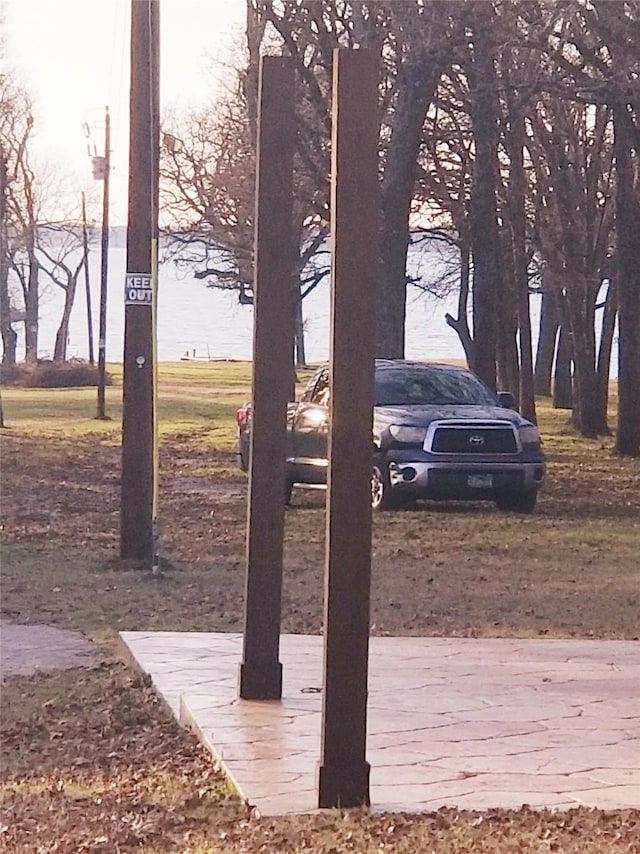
top-left (318, 49), bottom-right (379, 807)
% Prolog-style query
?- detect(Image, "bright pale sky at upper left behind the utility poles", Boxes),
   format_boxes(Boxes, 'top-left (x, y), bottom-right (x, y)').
top-left (0, 0), bottom-right (245, 225)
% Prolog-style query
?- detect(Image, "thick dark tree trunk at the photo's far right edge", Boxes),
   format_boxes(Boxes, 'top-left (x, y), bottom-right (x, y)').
top-left (614, 103), bottom-right (640, 457)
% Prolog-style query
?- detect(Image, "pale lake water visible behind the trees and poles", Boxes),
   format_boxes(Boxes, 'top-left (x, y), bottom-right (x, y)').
top-left (16, 241), bottom-right (615, 372)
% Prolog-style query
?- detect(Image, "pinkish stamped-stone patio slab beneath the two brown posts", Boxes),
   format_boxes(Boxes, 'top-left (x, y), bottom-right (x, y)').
top-left (120, 632), bottom-right (640, 815)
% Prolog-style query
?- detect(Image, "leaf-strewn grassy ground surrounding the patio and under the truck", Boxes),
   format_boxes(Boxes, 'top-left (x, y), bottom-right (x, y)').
top-left (0, 363), bottom-right (640, 854)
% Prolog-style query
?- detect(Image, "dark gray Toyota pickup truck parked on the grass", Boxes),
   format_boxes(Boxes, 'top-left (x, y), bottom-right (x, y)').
top-left (237, 359), bottom-right (546, 513)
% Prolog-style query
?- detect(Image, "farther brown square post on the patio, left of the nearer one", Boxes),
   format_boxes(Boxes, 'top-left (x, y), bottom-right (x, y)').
top-left (240, 56), bottom-right (295, 700)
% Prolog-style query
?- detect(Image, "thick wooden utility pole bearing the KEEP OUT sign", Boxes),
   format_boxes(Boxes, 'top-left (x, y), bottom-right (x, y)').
top-left (120, 0), bottom-right (160, 566)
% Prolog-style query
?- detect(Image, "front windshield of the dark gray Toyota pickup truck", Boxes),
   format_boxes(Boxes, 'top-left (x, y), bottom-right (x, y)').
top-left (376, 368), bottom-right (498, 406)
